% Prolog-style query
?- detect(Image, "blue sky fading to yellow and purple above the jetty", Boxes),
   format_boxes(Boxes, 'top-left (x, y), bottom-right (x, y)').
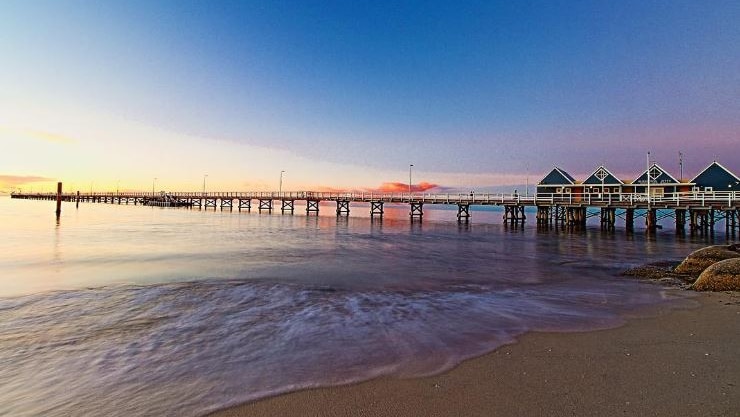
top-left (0, 0), bottom-right (740, 192)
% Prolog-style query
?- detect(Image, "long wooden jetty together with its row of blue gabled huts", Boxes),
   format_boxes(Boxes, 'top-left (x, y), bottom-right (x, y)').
top-left (11, 159), bottom-right (740, 235)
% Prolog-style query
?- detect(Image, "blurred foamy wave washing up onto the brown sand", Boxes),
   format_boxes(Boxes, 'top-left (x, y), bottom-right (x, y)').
top-left (0, 279), bottom-right (682, 416)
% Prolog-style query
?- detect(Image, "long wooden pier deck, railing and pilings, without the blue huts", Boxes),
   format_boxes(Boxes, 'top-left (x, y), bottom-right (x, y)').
top-left (11, 191), bottom-right (740, 235)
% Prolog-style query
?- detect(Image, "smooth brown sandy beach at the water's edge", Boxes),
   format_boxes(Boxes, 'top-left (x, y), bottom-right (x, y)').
top-left (213, 292), bottom-right (740, 417)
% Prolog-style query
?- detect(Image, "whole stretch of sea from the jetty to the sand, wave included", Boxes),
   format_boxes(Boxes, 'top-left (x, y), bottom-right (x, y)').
top-left (0, 198), bottom-right (728, 416)
